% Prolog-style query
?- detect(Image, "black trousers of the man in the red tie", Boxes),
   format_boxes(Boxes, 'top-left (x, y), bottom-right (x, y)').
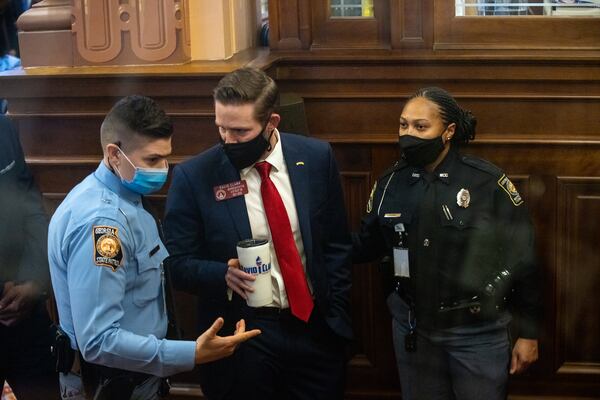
top-left (233, 307), bottom-right (346, 400)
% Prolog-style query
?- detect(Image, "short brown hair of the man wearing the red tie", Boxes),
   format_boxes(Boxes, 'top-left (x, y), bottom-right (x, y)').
top-left (213, 68), bottom-right (279, 123)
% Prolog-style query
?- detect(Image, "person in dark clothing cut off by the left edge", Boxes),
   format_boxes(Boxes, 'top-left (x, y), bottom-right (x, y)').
top-left (0, 111), bottom-right (59, 400)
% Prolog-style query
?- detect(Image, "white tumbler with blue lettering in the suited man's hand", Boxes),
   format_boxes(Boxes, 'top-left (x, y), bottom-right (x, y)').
top-left (237, 239), bottom-right (273, 307)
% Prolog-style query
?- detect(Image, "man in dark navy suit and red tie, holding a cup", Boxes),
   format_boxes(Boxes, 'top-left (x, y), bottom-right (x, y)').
top-left (165, 68), bottom-right (352, 399)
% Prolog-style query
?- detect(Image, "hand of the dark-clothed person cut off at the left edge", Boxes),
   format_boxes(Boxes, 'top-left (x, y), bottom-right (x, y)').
top-left (0, 281), bottom-right (41, 326)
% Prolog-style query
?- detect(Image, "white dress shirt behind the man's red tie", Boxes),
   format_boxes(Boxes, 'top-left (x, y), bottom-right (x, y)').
top-left (240, 129), bottom-right (312, 308)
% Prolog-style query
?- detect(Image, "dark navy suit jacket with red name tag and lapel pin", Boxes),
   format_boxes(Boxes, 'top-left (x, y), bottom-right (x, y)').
top-left (164, 133), bottom-right (352, 396)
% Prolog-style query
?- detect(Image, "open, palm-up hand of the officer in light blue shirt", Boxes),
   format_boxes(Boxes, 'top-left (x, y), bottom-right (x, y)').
top-left (196, 317), bottom-right (260, 364)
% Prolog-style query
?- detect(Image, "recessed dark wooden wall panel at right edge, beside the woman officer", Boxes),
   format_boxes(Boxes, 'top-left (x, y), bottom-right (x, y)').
top-left (555, 176), bottom-right (600, 374)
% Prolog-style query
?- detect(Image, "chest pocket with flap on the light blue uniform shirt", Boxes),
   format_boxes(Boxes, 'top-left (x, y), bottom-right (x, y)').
top-left (133, 243), bottom-right (168, 307)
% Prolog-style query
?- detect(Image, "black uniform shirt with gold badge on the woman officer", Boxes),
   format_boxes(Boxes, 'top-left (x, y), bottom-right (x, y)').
top-left (354, 149), bottom-right (540, 338)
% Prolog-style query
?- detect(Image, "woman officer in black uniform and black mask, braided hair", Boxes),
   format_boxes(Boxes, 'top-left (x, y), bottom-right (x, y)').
top-left (353, 88), bottom-right (541, 400)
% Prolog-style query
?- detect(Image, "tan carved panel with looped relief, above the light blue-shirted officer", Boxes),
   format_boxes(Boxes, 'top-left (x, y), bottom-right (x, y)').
top-left (72, 0), bottom-right (190, 65)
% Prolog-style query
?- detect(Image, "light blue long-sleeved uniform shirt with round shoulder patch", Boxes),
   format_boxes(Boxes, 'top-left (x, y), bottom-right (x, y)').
top-left (48, 162), bottom-right (196, 376)
